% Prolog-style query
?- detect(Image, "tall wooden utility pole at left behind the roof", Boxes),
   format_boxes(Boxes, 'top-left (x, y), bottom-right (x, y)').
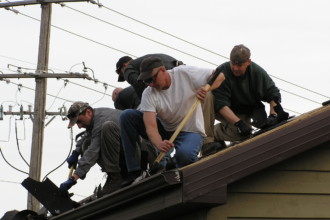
top-left (0, 0), bottom-right (87, 212)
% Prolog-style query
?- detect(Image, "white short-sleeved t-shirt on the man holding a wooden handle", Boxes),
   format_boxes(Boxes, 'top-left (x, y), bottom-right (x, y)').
top-left (140, 65), bottom-right (212, 136)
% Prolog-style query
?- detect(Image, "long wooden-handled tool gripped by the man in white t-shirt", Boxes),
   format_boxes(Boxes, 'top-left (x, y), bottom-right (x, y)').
top-left (148, 69), bottom-right (225, 175)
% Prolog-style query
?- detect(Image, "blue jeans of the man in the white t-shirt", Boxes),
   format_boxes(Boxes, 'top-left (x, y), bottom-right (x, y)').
top-left (120, 109), bottom-right (204, 172)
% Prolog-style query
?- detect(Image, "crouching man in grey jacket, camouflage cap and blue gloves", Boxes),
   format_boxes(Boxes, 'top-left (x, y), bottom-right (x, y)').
top-left (60, 101), bottom-right (125, 196)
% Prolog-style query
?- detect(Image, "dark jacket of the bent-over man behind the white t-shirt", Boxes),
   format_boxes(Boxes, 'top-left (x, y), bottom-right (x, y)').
top-left (124, 53), bottom-right (177, 99)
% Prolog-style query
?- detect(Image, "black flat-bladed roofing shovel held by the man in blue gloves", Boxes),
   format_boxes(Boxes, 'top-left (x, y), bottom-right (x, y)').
top-left (21, 167), bottom-right (80, 215)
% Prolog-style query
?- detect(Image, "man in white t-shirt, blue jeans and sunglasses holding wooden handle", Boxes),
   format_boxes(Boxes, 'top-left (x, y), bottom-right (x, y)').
top-left (120, 57), bottom-right (223, 182)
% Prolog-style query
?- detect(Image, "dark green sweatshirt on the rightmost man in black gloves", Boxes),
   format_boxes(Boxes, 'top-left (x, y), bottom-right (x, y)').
top-left (212, 62), bottom-right (281, 114)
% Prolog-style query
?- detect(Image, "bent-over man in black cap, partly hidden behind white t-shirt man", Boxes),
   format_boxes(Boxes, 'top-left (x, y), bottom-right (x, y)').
top-left (116, 54), bottom-right (183, 99)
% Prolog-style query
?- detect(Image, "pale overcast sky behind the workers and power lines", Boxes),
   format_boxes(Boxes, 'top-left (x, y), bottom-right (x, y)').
top-left (0, 0), bottom-right (330, 217)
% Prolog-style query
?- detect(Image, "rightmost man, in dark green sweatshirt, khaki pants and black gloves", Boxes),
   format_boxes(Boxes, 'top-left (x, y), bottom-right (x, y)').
top-left (202, 44), bottom-right (288, 153)
